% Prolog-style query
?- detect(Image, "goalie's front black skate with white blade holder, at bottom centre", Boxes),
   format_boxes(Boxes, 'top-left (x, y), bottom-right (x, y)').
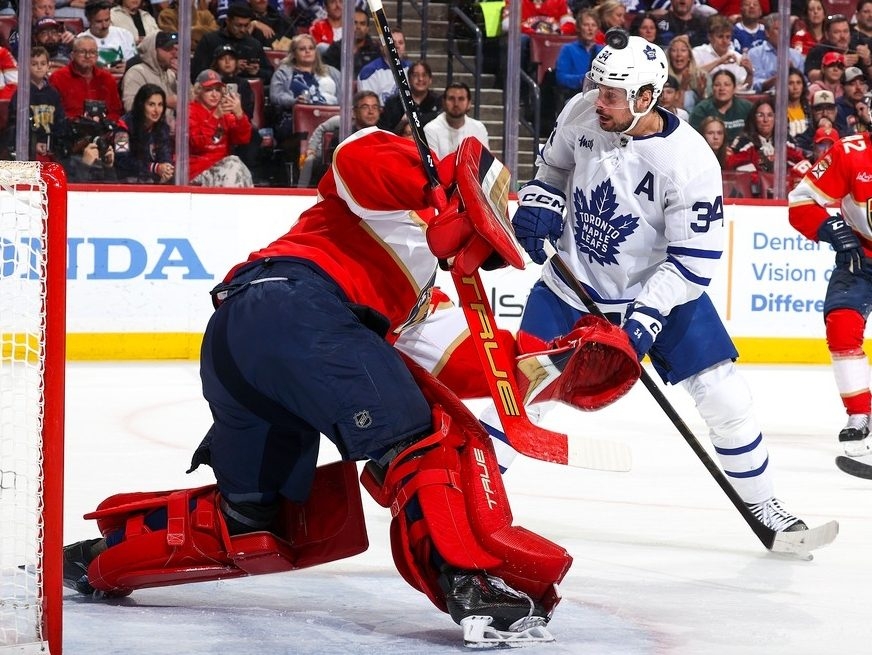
top-left (439, 569), bottom-right (554, 648)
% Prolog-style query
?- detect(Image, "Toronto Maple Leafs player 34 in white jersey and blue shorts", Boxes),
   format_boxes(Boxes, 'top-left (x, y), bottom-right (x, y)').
top-left (512, 30), bottom-right (807, 531)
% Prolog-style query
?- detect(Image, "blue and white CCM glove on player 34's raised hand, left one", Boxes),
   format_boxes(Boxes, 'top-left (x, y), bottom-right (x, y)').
top-left (512, 180), bottom-right (566, 264)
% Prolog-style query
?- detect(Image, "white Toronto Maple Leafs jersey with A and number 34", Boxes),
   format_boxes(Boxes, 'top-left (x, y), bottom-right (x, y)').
top-left (536, 91), bottom-right (724, 316)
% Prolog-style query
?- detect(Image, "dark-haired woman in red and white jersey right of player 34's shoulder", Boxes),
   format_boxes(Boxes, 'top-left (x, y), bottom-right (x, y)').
top-left (727, 98), bottom-right (805, 173)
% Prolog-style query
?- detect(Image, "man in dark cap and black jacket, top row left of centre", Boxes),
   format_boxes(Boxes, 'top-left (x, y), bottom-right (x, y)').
top-left (191, 4), bottom-right (273, 88)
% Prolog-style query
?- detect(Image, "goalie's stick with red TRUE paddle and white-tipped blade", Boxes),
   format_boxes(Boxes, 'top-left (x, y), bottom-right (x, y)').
top-left (369, 0), bottom-right (632, 471)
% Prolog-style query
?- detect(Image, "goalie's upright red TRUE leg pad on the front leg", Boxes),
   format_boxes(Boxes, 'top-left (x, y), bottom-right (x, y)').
top-left (362, 356), bottom-right (572, 612)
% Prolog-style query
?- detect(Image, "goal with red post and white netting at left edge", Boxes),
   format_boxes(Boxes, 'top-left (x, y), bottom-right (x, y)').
top-left (0, 161), bottom-right (67, 655)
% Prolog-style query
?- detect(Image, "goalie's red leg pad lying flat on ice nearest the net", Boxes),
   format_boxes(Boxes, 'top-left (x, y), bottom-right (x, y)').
top-left (85, 462), bottom-right (368, 596)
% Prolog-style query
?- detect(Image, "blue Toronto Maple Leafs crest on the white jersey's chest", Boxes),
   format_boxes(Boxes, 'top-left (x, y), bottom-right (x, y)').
top-left (572, 180), bottom-right (639, 266)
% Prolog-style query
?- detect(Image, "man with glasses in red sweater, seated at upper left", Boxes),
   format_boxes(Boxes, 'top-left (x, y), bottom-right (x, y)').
top-left (49, 36), bottom-right (122, 122)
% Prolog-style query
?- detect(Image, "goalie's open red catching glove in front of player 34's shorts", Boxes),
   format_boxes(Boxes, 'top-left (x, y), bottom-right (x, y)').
top-left (518, 314), bottom-right (642, 411)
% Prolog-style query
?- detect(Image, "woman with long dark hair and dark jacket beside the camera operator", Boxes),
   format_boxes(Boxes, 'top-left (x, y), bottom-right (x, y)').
top-left (115, 84), bottom-right (175, 184)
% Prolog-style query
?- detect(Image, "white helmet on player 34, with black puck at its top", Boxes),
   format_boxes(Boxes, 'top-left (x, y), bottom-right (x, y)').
top-left (587, 28), bottom-right (669, 110)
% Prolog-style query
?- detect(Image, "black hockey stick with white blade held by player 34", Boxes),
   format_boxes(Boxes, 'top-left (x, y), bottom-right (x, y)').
top-left (545, 239), bottom-right (839, 559)
